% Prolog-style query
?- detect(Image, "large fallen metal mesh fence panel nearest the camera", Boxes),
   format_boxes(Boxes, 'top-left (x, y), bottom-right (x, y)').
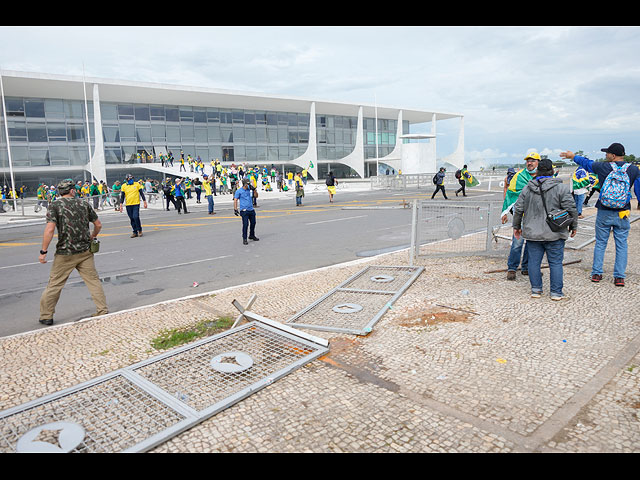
top-left (0, 318), bottom-right (328, 453)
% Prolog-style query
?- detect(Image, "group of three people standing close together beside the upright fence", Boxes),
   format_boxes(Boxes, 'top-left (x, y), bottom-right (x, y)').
top-left (502, 143), bottom-right (640, 301)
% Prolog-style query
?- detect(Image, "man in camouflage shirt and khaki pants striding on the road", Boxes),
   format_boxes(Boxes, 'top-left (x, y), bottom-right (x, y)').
top-left (39, 180), bottom-right (108, 325)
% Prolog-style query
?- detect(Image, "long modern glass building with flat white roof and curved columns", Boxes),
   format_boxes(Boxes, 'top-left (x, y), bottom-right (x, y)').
top-left (0, 71), bottom-right (464, 191)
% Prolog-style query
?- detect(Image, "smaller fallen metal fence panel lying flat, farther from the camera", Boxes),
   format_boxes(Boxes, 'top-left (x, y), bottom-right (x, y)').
top-left (286, 265), bottom-right (424, 335)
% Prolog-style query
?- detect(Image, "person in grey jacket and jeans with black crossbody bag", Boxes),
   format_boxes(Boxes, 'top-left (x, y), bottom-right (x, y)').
top-left (513, 158), bottom-right (578, 300)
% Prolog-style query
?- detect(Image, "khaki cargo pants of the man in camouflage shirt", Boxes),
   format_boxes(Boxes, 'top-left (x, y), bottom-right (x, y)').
top-left (40, 250), bottom-right (109, 320)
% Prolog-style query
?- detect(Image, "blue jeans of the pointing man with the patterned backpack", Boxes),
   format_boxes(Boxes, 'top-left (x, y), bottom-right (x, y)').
top-left (591, 209), bottom-right (630, 278)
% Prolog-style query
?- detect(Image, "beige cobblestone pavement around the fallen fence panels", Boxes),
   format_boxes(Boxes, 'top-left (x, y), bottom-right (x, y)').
top-left (0, 208), bottom-right (640, 453)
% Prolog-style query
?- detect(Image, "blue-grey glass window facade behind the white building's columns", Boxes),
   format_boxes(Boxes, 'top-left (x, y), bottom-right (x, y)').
top-left (0, 97), bottom-right (409, 172)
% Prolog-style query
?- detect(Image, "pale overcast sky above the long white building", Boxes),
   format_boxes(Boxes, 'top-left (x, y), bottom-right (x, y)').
top-left (0, 26), bottom-right (640, 169)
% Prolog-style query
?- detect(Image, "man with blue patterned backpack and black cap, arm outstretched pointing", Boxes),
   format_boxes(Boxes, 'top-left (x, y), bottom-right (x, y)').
top-left (560, 143), bottom-right (640, 287)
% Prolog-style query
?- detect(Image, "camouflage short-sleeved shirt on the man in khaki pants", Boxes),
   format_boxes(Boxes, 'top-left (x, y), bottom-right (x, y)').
top-left (47, 198), bottom-right (98, 255)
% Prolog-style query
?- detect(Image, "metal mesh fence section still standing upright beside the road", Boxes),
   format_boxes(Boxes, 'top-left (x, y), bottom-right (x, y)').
top-left (410, 200), bottom-right (504, 264)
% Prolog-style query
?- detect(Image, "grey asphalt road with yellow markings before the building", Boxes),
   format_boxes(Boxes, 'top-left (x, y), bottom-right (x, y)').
top-left (0, 191), bottom-right (500, 336)
